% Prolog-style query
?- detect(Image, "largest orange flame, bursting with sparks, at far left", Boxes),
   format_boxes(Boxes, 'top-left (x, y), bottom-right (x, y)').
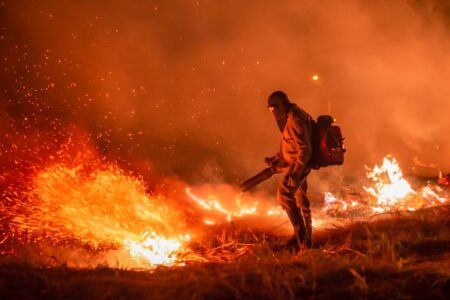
top-left (11, 164), bottom-right (190, 266)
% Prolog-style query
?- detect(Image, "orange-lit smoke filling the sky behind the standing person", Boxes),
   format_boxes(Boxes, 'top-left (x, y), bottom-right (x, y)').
top-left (0, 0), bottom-right (450, 189)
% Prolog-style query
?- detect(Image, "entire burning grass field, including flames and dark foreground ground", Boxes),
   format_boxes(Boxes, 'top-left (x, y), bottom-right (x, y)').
top-left (0, 140), bottom-right (450, 298)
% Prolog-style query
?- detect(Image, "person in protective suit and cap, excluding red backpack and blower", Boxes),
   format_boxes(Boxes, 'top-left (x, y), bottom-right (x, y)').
top-left (265, 91), bottom-right (312, 251)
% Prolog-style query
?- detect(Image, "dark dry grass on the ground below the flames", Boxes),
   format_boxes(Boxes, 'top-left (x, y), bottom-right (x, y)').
top-left (0, 206), bottom-right (450, 299)
